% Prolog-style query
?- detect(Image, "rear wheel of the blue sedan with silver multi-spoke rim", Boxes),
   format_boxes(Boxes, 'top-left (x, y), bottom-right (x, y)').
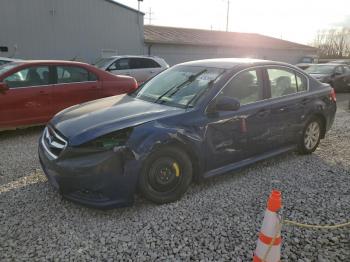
top-left (298, 117), bottom-right (323, 155)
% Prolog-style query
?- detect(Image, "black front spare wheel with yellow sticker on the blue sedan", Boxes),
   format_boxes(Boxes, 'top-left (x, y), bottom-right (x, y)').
top-left (138, 147), bottom-right (193, 204)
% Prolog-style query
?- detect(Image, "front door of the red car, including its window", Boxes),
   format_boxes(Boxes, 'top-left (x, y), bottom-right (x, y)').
top-left (0, 66), bottom-right (53, 127)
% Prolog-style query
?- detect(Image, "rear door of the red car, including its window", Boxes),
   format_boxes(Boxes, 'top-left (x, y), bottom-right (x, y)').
top-left (53, 65), bottom-right (103, 113)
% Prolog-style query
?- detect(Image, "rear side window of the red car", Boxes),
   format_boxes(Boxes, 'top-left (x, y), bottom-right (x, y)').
top-left (56, 66), bottom-right (97, 84)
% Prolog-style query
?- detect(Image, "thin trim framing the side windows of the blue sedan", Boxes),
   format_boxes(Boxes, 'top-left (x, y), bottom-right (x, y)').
top-left (204, 64), bottom-right (310, 113)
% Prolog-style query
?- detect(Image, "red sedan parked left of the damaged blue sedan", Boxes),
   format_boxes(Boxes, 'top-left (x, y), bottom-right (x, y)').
top-left (0, 61), bottom-right (137, 130)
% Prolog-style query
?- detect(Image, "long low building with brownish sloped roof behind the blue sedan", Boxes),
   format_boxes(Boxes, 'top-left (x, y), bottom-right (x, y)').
top-left (144, 25), bottom-right (317, 65)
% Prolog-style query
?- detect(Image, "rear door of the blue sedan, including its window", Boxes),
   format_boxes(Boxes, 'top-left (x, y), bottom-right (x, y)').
top-left (265, 66), bottom-right (312, 148)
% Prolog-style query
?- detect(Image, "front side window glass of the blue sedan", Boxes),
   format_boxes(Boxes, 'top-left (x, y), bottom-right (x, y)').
top-left (220, 70), bottom-right (263, 105)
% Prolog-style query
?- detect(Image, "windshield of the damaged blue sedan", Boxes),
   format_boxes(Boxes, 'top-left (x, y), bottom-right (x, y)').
top-left (132, 66), bottom-right (225, 108)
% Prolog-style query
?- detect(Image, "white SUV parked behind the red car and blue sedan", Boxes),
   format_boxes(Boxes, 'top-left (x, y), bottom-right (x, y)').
top-left (95, 56), bottom-right (169, 84)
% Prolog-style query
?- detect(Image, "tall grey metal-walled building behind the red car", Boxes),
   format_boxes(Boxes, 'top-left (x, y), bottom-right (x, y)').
top-left (0, 0), bottom-right (144, 62)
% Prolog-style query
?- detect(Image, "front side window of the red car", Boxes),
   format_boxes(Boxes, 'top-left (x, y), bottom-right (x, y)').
top-left (4, 66), bottom-right (50, 88)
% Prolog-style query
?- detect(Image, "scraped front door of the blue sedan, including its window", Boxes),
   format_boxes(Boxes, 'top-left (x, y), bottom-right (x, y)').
top-left (205, 69), bottom-right (271, 170)
